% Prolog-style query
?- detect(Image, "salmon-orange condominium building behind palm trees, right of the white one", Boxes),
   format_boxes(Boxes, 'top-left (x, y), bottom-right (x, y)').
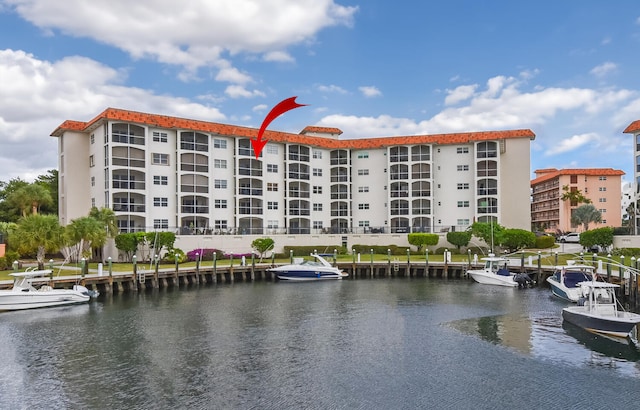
top-left (531, 168), bottom-right (624, 232)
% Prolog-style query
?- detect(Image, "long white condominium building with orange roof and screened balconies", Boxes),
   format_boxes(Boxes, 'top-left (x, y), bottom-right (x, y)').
top-left (52, 108), bottom-right (535, 235)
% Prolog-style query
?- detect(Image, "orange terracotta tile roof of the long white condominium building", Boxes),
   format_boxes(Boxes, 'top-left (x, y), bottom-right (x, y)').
top-left (51, 108), bottom-right (535, 149)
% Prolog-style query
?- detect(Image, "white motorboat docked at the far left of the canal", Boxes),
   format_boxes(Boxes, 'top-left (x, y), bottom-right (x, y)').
top-left (0, 269), bottom-right (98, 311)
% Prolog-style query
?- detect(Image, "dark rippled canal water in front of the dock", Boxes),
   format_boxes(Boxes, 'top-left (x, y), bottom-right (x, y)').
top-left (0, 278), bottom-right (640, 409)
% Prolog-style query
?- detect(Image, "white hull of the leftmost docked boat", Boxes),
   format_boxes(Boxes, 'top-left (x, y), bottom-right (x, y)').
top-left (0, 289), bottom-right (90, 311)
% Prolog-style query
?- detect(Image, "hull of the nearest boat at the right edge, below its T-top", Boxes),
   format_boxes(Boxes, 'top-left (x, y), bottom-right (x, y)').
top-left (562, 306), bottom-right (640, 338)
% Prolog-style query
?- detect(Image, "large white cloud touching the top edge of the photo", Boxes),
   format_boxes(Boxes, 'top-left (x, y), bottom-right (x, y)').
top-left (5, 0), bottom-right (358, 78)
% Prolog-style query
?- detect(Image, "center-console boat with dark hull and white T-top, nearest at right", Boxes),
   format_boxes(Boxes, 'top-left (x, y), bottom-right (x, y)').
top-left (562, 280), bottom-right (640, 338)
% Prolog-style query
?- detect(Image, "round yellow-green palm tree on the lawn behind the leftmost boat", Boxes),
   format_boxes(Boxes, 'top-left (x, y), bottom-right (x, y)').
top-left (9, 215), bottom-right (64, 269)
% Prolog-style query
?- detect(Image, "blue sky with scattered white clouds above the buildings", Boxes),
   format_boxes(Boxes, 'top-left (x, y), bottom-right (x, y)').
top-left (0, 0), bottom-right (640, 182)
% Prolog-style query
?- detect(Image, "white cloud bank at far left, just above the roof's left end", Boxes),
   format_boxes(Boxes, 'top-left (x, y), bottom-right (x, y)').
top-left (0, 50), bottom-right (226, 181)
